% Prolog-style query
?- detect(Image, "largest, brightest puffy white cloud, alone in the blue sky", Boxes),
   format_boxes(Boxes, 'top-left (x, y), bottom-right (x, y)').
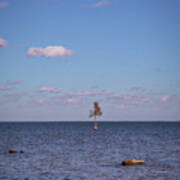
top-left (27, 46), bottom-right (72, 58)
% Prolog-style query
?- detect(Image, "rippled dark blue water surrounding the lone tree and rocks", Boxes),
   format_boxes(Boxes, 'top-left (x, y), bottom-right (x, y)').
top-left (0, 122), bottom-right (180, 180)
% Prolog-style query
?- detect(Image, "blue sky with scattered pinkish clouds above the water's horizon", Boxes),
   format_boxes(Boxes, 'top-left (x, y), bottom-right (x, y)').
top-left (0, 0), bottom-right (180, 121)
